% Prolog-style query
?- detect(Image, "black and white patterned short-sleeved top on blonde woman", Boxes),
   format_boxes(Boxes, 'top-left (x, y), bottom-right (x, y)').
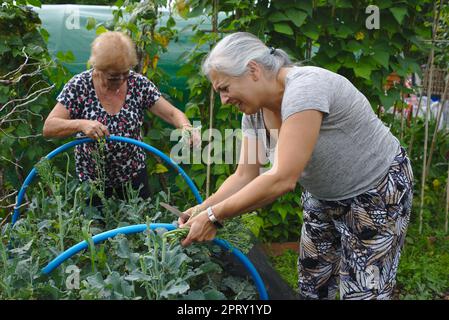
top-left (57, 69), bottom-right (161, 187)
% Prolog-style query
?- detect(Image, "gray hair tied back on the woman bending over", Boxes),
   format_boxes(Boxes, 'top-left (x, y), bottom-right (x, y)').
top-left (202, 32), bottom-right (292, 77)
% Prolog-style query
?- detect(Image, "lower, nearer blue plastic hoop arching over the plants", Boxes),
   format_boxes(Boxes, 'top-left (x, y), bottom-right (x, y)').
top-left (42, 223), bottom-right (268, 300)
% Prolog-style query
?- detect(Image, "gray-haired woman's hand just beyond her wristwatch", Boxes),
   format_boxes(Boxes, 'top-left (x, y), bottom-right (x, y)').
top-left (181, 211), bottom-right (217, 247)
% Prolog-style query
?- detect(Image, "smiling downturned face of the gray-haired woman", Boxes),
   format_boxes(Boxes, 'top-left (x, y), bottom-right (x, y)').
top-left (209, 70), bottom-right (262, 114)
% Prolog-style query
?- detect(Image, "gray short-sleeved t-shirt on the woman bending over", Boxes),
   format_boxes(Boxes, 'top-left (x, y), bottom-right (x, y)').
top-left (242, 67), bottom-right (400, 200)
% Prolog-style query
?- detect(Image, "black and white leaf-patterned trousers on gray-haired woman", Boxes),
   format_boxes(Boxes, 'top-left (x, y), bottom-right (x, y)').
top-left (298, 148), bottom-right (413, 299)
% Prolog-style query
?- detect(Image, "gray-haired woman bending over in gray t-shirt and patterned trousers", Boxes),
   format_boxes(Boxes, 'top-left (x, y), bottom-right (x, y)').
top-left (180, 33), bottom-right (413, 299)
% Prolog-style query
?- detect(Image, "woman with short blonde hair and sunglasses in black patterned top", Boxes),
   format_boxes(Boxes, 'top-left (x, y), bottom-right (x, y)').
top-left (43, 32), bottom-right (191, 205)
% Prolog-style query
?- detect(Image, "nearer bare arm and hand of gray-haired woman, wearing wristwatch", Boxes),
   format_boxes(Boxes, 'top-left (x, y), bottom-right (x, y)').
top-left (182, 110), bottom-right (323, 246)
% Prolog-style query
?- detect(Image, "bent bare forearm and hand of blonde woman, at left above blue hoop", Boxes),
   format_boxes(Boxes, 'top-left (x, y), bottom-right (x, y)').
top-left (42, 102), bottom-right (109, 139)
